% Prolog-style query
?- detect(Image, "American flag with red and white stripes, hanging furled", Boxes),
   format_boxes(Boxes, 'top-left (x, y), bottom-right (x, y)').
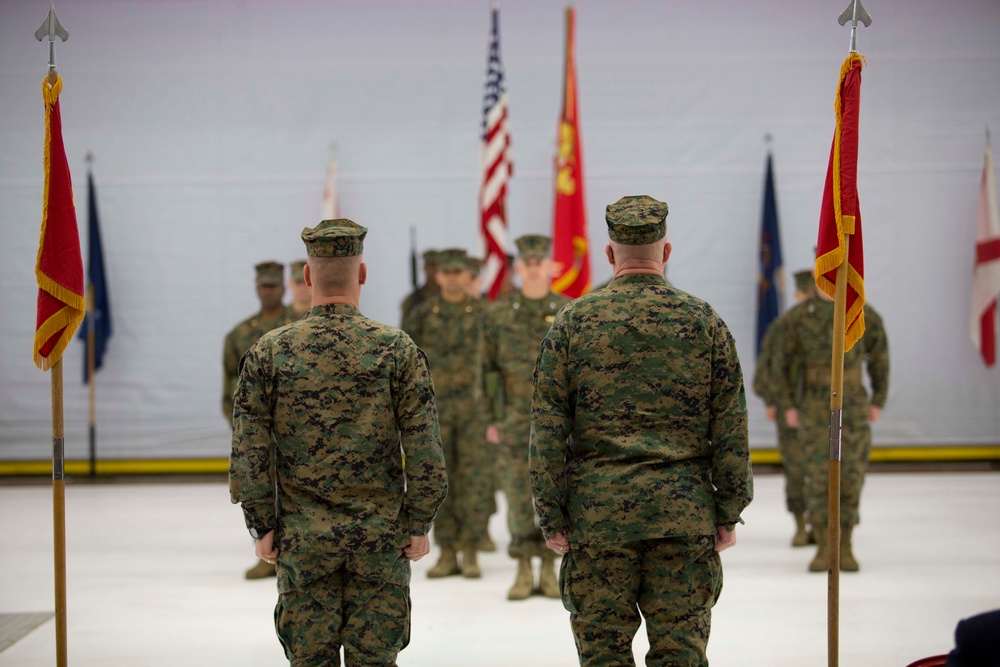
top-left (479, 5), bottom-right (514, 299)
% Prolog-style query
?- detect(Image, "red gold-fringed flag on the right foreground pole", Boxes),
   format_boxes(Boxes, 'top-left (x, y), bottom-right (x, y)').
top-left (816, 53), bottom-right (865, 352)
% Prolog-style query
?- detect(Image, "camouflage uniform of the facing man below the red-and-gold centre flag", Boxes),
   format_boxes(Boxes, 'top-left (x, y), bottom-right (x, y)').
top-left (484, 237), bottom-right (569, 558)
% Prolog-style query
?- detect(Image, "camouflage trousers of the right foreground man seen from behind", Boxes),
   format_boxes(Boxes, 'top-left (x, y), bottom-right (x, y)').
top-left (559, 536), bottom-right (722, 667)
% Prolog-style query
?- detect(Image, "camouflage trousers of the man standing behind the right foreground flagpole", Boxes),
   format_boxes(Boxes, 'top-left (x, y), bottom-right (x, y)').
top-left (799, 392), bottom-right (872, 528)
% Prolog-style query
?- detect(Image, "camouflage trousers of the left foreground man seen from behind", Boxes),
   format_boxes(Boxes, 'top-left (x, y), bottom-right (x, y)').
top-left (274, 551), bottom-right (410, 667)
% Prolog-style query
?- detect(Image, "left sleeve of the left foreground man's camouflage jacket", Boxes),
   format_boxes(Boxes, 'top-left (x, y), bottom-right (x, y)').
top-left (229, 339), bottom-right (277, 527)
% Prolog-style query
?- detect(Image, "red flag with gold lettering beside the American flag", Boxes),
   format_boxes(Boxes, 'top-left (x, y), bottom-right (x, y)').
top-left (552, 7), bottom-right (590, 299)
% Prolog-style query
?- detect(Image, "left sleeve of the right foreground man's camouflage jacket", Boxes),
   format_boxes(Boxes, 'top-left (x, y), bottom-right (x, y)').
top-left (528, 313), bottom-right (573, 537)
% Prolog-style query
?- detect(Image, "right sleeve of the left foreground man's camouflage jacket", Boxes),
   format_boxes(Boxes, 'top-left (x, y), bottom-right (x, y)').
top-left (394, 337), bottom-right (448, 535)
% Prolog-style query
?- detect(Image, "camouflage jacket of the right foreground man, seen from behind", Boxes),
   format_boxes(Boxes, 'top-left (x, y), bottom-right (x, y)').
top-left (530, 275), bottom-right (753, 544)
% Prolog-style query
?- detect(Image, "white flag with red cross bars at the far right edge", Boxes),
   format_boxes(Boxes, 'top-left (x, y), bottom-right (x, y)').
top-left (969, 138), bottom-right (1000, 367)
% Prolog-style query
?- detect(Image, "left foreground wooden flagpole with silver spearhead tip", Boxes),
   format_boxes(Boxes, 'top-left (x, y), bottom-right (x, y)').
top-left (35, 0), bottom-right (75, 667)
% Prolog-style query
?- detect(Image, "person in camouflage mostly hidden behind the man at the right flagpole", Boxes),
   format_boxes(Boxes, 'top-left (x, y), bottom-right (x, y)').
top-left (753, 271), bottom-right (816, 547)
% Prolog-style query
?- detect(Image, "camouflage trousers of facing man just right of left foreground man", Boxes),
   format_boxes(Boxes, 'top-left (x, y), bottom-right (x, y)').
top-left (434, 398), bottom-right (496, 549)
